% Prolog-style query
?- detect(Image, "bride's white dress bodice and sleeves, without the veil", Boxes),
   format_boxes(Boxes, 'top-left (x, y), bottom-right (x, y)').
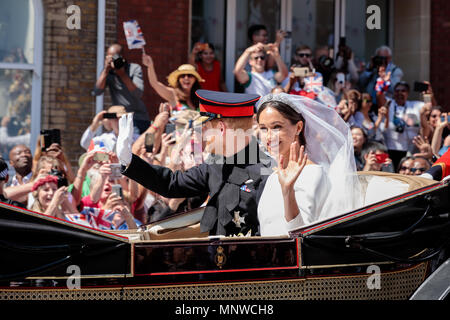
top-left (258, 164), bottom-right (331, 236)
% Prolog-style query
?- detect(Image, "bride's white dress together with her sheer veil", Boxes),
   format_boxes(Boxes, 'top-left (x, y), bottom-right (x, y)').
top-left (257, 93), bottom-right (363, 236)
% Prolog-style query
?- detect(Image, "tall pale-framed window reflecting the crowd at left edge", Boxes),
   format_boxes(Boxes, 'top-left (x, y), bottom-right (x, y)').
top-left (0, 0), bottom-right (42, 160)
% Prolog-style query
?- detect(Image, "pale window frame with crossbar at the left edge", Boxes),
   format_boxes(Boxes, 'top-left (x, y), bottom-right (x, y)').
top-left (0, 0), bottom-right (44, 153)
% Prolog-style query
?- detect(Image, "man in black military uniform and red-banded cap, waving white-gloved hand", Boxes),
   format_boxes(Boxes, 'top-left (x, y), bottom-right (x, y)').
top-left (117, 90), bottom-right (271, 236)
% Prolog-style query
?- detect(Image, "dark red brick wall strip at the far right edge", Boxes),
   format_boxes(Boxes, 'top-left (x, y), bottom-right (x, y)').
top-left (430, 0), bottom-right (450, 111)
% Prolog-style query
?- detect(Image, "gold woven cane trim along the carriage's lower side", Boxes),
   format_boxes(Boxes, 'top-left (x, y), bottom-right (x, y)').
top-left (0, 262), bottom-right (427, 300)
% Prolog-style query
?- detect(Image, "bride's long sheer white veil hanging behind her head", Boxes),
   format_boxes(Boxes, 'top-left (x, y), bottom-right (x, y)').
top-left (257, 93), bottom-right (363, 220)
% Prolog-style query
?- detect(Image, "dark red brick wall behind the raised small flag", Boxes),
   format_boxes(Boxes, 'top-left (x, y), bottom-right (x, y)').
top-left (117, 0), bottom-right (190, 118)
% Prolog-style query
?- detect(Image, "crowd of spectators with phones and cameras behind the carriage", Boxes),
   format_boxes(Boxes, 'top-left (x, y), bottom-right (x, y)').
top-left (0, 25), bottom-right (450, 230)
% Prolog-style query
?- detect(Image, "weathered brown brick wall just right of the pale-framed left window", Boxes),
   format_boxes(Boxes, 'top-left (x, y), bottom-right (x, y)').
top-left (41, 0), bottom-right (117, 167)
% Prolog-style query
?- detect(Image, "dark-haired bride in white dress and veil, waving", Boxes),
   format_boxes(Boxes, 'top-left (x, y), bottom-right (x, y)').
top-left (257, 93), bottom-right (362, 236)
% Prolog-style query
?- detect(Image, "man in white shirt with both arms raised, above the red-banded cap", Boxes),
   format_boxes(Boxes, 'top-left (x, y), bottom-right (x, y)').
top-left (234, 43), bottom-right (288, 96)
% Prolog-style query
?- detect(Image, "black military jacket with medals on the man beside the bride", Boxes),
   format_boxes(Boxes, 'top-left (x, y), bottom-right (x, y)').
top-left (123, 139), bottom-right (272, 235)
